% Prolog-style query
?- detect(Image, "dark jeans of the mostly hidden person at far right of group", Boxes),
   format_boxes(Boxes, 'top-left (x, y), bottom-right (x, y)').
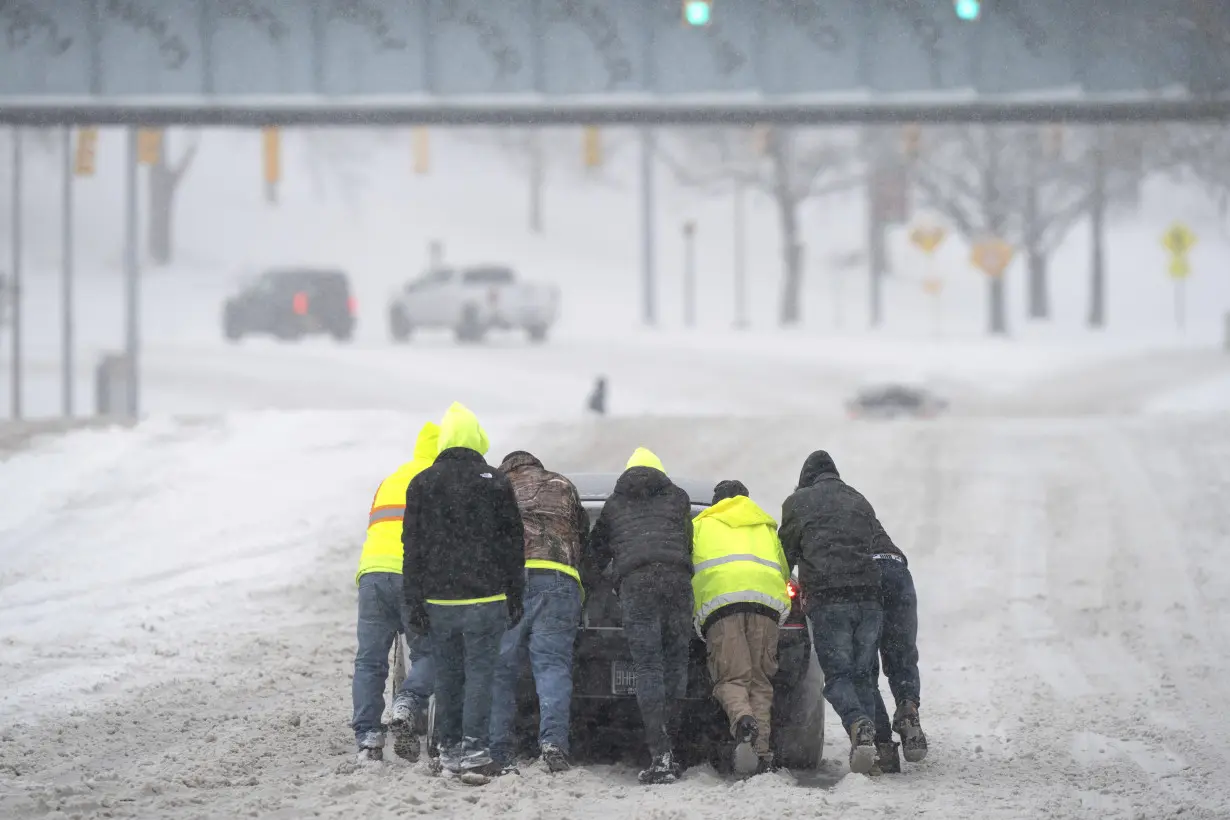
top-left (876, 558), bottom-right (920, 743)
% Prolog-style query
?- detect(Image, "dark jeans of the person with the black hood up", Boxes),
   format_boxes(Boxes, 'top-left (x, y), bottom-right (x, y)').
top-left (809, 601), bottom-right (884, 734)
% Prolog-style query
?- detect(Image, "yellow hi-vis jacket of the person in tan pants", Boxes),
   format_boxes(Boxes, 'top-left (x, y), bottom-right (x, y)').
top-left (692, 495), bottom-right (790, 638)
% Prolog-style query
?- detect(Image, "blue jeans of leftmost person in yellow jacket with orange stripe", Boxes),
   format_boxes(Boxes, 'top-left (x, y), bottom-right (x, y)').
top-left (351, 573), bottom-right (434, 738)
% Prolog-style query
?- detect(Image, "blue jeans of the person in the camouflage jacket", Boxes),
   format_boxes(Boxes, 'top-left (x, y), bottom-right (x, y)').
top-left (491, 569), bottom-right (581, 763)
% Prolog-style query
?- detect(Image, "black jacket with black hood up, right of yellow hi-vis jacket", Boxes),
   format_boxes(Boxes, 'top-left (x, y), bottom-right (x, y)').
top-left (779, 450), bottom-right (891, 602)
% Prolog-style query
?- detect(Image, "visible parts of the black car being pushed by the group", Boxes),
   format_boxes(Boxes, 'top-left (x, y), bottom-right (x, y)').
top-left (484, 473), bottom-right (824, 772)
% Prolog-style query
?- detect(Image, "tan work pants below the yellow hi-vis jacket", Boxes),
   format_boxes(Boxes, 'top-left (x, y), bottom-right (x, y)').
top-left (705, 612), bottom-right (777, 757)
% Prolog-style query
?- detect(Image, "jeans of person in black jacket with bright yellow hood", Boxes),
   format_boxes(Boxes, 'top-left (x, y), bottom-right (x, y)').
top-left (427, 601), bottom-right (508, 749)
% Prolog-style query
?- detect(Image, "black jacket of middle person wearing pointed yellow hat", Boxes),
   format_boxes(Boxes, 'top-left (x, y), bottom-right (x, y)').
top-left (587, 467), bottom-right (692, 589)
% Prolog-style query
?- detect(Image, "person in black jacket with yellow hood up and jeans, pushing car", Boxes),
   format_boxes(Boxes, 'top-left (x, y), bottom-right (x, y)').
top-left (402, 403), bottom-right (524, 772)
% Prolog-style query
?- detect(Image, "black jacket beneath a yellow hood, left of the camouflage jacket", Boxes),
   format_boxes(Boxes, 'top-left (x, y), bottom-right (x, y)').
top-left (401, 447), bottom-right (525, 610)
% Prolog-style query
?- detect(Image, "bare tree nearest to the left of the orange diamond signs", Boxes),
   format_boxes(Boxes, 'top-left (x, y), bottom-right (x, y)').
top-left (659, 128), bottom-right (865, 327)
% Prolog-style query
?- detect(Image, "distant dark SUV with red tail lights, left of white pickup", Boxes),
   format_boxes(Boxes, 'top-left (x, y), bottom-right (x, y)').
top-left (223, 268), bottom-right (355, 342)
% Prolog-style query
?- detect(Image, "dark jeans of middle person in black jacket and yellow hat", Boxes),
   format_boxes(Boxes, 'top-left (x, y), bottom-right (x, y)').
top-left (619, 564), bottom-right (694, 756)
